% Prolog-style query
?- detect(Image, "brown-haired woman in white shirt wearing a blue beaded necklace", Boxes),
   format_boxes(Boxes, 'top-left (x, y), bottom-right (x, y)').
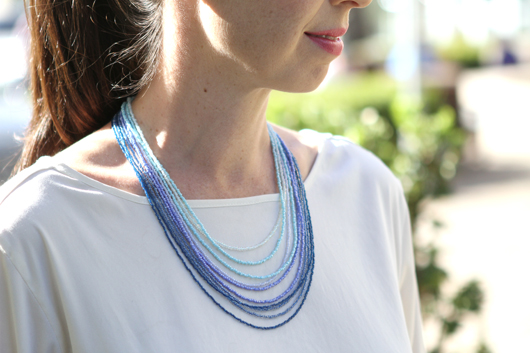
top-left (0, 0), bottom-right (423, 353)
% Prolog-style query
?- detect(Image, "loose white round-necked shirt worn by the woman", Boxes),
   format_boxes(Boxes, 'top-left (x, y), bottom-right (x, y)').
top-left (0, 131), bottom-right (424, 353)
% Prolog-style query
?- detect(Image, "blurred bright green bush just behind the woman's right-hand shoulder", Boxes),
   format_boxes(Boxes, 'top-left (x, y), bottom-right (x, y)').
top-left (267, 73), bottom-right (465, 223)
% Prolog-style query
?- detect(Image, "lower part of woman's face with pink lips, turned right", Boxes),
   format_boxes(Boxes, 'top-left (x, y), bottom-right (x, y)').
top-left (199, 0), bottom-right (370, 92)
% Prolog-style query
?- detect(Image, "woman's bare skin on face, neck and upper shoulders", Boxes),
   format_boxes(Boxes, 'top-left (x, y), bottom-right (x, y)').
top-left (58, 0), bottom-right (370, 199)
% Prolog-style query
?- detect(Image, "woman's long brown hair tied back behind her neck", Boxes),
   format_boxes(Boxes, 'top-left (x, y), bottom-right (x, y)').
top-left (13, 0), bottom-right (162, 173)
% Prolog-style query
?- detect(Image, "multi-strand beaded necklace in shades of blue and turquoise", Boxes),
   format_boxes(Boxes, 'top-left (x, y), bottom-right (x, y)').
top-left (112, 98), bottom-right (314, 329)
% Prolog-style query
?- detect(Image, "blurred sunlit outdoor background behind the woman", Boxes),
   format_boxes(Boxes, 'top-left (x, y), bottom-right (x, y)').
top-left (0, 0), bottom-right (530, 353)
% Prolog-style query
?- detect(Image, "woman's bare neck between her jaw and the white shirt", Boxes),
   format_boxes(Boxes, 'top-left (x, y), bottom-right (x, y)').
top-left (132, 42), bottom-right (277, 199)
